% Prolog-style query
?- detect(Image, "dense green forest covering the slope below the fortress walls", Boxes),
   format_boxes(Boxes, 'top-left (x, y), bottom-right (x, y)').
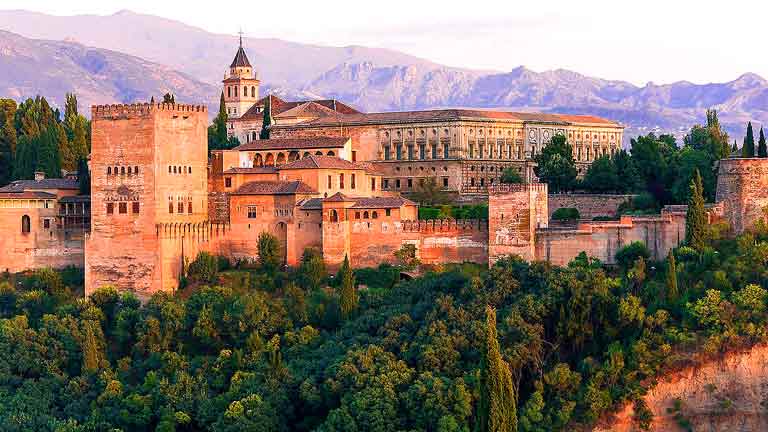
top-left (0, 183), bottom-right (768, 432)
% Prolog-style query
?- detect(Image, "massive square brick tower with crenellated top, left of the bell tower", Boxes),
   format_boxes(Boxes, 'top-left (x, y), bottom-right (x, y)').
top-left (85, 104), bottom-right (208, 296)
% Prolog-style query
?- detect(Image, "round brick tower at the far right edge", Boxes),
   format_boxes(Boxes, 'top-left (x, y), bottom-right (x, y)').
top-left (715, 158), bottom-right (768, 233)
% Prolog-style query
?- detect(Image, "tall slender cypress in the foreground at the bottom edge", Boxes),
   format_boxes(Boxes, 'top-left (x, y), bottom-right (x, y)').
top-left (476, 306), bottom-right (517, 432)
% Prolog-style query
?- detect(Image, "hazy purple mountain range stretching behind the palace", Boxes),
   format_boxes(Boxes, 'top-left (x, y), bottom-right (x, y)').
top-left (0, 11), bottom-right (768, 140)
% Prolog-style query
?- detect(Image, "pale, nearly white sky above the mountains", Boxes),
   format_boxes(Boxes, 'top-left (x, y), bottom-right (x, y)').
top-left (0, 0), bottom-right (768, 85)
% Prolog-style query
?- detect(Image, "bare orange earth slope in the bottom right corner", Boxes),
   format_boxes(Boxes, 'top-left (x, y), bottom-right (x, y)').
top-left (593, 345), bottom-right (768, 432)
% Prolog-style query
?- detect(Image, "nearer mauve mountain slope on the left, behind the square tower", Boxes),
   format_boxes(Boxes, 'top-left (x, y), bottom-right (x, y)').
top-left (0, 31), bottom-right (219, 109)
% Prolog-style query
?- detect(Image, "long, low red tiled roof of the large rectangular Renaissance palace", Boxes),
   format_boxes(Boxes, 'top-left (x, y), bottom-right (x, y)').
top-left (274, 109), bottom-right (619, 128)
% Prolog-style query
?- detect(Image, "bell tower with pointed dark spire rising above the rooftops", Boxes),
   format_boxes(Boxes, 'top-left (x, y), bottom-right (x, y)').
top-left (223, 32), bottom-right (260, 119)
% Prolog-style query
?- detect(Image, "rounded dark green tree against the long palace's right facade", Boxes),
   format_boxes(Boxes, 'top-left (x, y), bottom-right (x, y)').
top-left (534, 134), bottom-right (577, 192)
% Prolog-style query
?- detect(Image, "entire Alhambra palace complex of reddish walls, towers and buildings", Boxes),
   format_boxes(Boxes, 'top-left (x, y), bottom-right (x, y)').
top-left (0, 42), bottom-right (768, 297)
